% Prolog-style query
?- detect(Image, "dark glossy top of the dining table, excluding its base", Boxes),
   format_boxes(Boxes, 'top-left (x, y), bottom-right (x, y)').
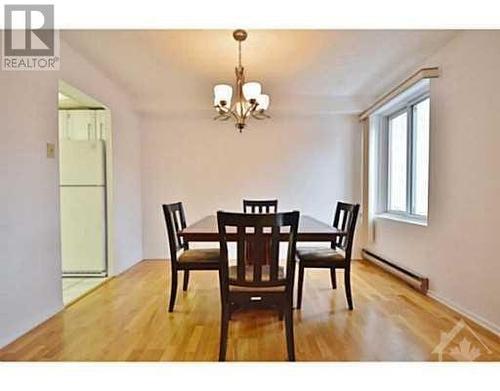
top-left (179, 215), bottom-right (347, 242)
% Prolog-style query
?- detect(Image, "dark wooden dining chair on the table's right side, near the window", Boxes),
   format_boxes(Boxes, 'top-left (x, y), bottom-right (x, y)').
top-left (297, 202), bottom-right (359, 311)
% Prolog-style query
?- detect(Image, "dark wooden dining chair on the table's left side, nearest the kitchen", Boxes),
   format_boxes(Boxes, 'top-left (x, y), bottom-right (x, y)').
top-left (163, 202), bottom-right (220, 312)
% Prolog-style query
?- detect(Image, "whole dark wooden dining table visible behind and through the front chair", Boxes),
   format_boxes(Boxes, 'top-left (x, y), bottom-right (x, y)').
top-left (179, 215), bottom-right (347, 263)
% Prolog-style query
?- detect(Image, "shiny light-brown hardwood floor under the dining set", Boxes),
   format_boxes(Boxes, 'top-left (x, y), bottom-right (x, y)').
top-left (0, 261), bottom-right (500, 361)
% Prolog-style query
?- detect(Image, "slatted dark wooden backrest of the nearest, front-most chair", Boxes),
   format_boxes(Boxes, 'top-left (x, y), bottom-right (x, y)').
top-left (217, 211), bottom-right (300, 293)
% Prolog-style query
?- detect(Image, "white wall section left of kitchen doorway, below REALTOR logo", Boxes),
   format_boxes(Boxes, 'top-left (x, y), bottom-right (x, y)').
top-left (0, 71), bottom-right (62, 346)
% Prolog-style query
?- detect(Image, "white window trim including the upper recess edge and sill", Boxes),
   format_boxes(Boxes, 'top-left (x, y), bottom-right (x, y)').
top-left (370, 79), bottom-right (430, 226)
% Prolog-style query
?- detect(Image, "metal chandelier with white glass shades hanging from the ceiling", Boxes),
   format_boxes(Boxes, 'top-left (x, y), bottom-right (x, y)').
top-left (214, 30), bottom-right (270, 133)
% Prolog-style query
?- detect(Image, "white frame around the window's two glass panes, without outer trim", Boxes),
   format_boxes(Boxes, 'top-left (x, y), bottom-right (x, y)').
top-left (381, 91), bottom-right (430, 222)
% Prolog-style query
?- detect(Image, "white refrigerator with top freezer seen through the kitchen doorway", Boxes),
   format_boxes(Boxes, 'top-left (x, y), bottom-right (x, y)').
top-left (59, 139), bottom-right (107, 276)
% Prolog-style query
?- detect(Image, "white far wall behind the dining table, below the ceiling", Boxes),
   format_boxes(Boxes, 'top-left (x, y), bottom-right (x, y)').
top-left (142, 112), bottom-right (361, 258)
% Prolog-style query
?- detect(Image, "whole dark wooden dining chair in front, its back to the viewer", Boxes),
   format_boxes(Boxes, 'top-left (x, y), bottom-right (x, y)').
top-left (217, 211), bottom-right (299, 361)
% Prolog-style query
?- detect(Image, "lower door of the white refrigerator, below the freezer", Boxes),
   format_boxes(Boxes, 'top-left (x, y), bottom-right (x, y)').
top-left (61, 187), bottom-right (106, 274)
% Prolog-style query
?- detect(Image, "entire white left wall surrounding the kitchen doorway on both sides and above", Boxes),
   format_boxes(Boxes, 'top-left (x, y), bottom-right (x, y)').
top-left (0, 37), bottom-right (142, 346)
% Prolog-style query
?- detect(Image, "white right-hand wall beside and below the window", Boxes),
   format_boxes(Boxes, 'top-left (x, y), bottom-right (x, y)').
top-left (368, 31), bottom-right (500, 332)
